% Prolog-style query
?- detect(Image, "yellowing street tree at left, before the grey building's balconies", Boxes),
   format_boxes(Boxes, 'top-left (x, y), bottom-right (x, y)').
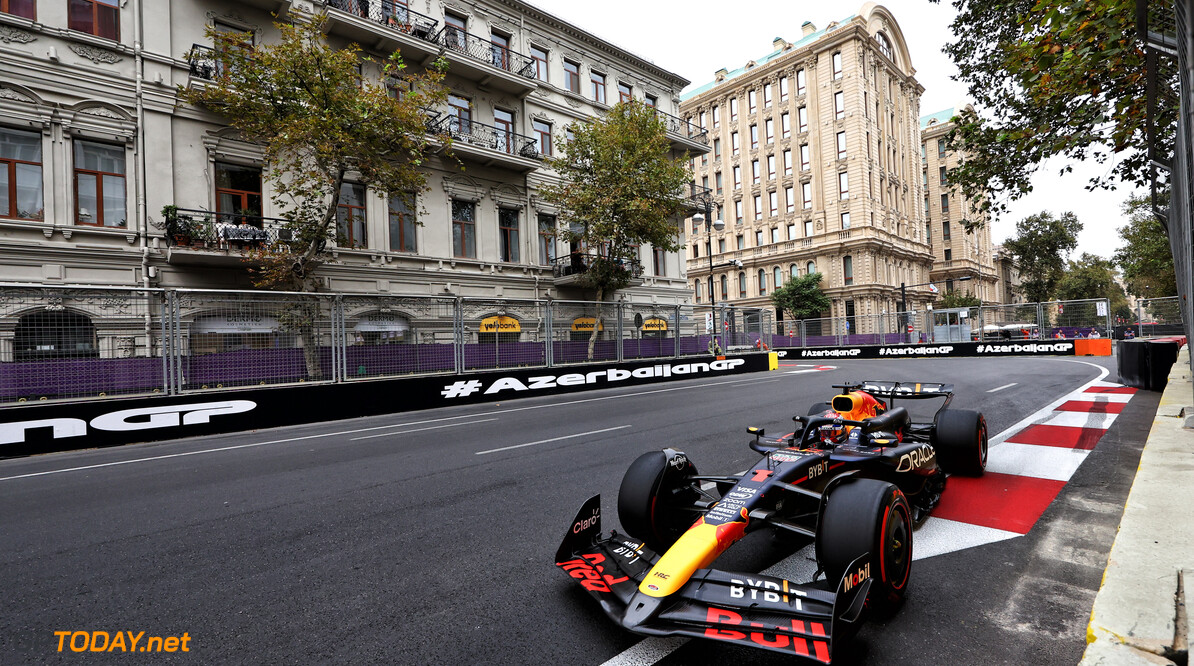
top-left (178, 14), bottom-right (447, 378)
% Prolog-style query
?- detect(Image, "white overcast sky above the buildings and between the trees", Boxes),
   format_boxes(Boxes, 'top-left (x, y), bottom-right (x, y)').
top-left (529, 0), bottom-right (1131, 257)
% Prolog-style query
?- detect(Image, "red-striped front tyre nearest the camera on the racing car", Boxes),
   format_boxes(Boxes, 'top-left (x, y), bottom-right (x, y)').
top-left (817, 479), bottom-right (912, 611)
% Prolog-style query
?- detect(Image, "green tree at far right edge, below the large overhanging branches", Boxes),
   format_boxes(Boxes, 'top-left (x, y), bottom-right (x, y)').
top-left (1114, 196), bottom-right (1177, 298)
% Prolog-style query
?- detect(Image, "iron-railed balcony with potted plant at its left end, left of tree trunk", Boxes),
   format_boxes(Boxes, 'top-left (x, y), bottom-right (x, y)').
top-left (165, 208), bottom-right (294, 264)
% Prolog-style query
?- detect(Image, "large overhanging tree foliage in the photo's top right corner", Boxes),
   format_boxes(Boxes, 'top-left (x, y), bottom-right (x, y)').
top-left (933, 0), bottom-right (1177, 224)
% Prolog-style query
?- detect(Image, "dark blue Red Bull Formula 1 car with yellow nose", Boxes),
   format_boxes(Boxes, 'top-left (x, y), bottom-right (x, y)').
top-left (555, 382), bottom-right (987, 664)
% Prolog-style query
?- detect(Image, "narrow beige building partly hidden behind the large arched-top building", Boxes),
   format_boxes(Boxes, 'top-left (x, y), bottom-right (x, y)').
top-left (921, 109), bottom-right (1004, 304)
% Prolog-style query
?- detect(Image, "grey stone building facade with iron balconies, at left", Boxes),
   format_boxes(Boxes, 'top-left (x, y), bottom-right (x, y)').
top-left (0, 0), bottom-right (709, 304)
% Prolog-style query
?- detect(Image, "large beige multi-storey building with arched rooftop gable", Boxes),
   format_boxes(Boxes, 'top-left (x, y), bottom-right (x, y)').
top-left (681, 2), bottom-right (934, 333)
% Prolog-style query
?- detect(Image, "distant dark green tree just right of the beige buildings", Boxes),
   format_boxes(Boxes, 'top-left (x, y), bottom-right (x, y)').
top-left (1003, 211), bottom-right (1082, 303)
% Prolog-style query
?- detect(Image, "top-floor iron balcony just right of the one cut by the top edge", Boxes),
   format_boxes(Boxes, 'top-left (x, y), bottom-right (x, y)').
top-left (435, 25), bottom-right (538, 94)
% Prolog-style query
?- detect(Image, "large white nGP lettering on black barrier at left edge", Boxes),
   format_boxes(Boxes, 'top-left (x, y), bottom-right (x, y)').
top-left (0, 400), bottom-right (257, 444)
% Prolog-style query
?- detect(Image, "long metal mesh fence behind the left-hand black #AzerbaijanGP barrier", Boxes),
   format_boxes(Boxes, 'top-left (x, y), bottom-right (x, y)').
top-left (0, 285), bottom-right (771, 405)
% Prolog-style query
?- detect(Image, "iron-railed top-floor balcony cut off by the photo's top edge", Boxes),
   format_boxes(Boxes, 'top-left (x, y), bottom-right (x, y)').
top-left (327, 0), bottom-right (441, 61)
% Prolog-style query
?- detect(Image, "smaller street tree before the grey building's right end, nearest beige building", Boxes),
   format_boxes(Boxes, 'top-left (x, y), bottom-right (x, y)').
top-left (540, 100), bottom-right (690, 359)
